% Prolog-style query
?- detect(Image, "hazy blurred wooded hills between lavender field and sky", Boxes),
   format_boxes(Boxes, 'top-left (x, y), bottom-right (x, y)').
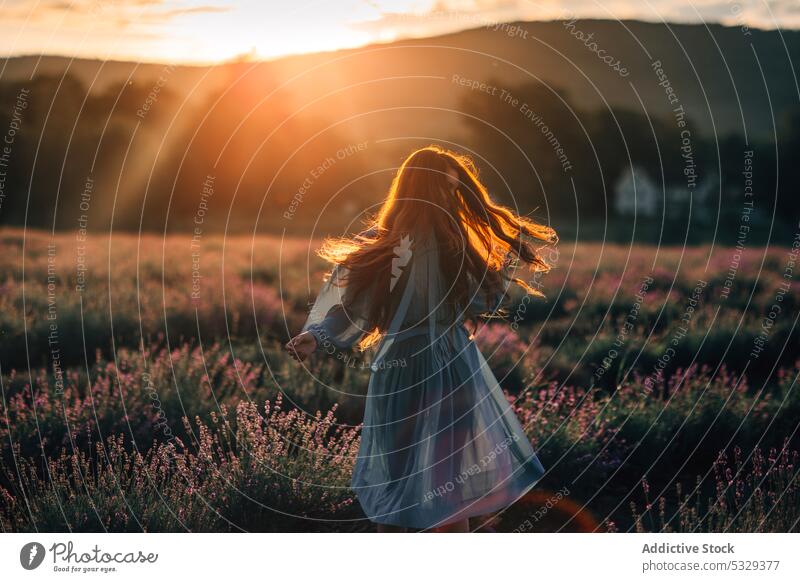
top-left (0, 2), bottom-right (800, 244)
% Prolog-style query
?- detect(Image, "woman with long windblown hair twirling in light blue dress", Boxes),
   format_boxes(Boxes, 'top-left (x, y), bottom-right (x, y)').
top-left (286, 146), bottom-right (558, 531)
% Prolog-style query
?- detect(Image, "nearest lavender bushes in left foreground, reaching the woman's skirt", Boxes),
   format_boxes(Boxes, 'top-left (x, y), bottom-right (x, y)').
top-left (0, 398), bottom-right (364, 532)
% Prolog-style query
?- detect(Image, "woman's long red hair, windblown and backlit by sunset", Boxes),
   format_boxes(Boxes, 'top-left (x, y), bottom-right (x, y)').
top-left (318, 145), bottom-right (558, 349)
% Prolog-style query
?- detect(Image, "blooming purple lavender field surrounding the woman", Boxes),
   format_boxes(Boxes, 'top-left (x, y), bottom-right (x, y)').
top-left (0, 229), bottom-right (800, 532)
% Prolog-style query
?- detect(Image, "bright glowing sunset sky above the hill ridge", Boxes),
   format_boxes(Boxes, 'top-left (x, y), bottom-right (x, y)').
top-left (0, 0), bottom-right (800, 63)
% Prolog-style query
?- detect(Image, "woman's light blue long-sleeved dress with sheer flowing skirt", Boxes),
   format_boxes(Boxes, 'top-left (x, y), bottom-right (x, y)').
top-left (303, 231), bottom-right (544, 529)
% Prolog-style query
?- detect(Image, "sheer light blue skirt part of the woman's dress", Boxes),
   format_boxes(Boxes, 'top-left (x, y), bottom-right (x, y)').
top-left (352, 326), bottom-right (544, 529)
